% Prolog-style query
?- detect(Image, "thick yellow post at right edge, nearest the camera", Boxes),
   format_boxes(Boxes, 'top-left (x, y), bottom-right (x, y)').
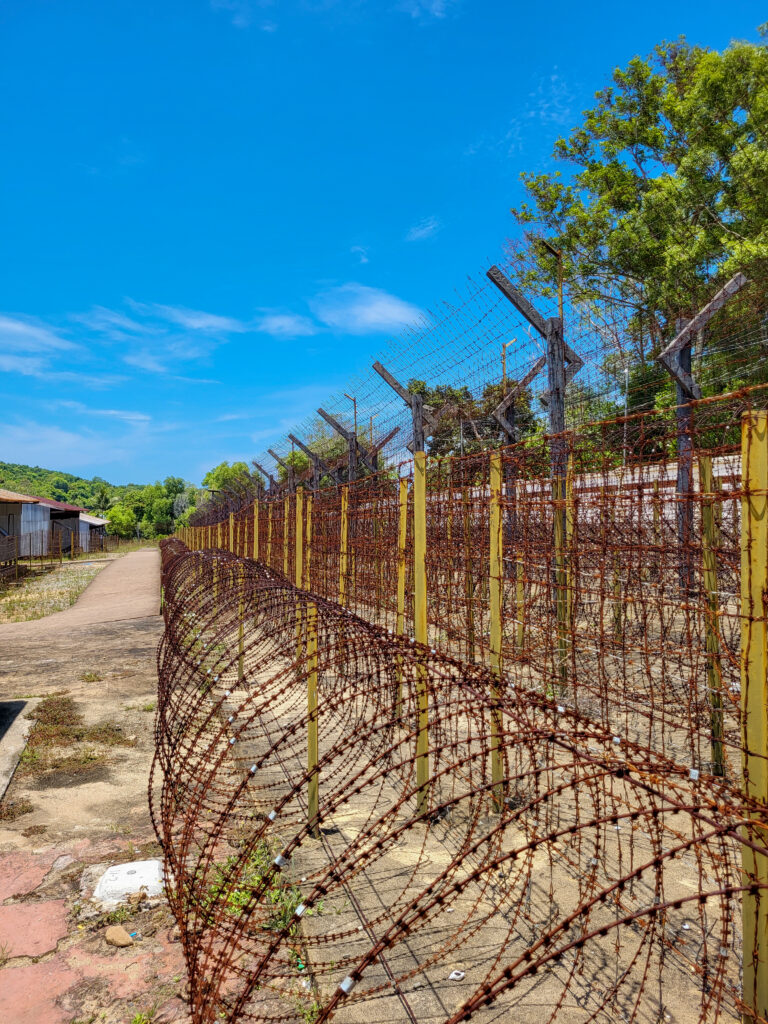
top-left (741, 412), bottom-right (768, 1022)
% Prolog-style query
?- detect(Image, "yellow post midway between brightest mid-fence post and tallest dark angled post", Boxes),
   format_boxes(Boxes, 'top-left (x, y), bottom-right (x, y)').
top-left (488, 452), bottom-right (504, 812)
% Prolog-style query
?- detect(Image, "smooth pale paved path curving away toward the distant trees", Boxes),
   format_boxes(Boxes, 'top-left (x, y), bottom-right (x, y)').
top-left (0, 548), bottom-right (160, 645)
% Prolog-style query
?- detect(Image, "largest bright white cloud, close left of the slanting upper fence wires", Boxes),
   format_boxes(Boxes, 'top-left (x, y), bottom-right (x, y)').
top-left (309, 283), bottom-right (424, 334)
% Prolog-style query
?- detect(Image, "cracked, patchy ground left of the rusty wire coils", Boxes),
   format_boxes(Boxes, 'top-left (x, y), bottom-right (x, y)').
top-left (0, 549), bottom-right (188, 1024)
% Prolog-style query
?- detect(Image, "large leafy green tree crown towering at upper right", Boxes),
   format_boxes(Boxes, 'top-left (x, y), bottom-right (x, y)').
top-left (512, 39), bottom-right (768, 362)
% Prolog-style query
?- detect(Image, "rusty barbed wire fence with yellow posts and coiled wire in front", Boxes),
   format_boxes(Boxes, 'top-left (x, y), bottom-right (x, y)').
top-left (157, 387), bottom-right (768, 1022)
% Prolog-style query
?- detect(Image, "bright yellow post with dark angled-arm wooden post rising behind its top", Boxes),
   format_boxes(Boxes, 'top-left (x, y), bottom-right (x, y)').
top-left (414, 451), bottom-right (429, 814)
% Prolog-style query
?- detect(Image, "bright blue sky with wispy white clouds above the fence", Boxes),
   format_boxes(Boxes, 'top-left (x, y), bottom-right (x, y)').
top-left (0, 0), bottom-right (766, 483)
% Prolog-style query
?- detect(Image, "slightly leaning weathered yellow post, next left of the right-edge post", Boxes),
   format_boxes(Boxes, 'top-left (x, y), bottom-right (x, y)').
top-left (698, 455), bottom-right (725, 775)
